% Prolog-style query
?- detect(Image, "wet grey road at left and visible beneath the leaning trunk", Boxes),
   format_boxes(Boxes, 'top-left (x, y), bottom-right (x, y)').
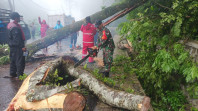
top-left (0, 35), bottom-right (82, 111)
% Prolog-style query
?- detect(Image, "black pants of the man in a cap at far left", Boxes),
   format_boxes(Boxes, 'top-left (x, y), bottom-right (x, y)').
top-left (10, 48), bottom-right (25, 77)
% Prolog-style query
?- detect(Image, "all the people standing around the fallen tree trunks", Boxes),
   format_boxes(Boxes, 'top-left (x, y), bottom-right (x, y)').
top-left (7, 12), bottom-right (115, 77)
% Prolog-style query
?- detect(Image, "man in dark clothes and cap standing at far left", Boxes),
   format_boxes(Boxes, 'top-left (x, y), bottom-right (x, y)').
top-left (7, 12), bottom-right (26, 78)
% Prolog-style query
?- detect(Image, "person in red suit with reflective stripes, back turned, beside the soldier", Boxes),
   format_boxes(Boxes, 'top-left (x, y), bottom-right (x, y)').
top-left (80, 16), bottom-right (96, 63)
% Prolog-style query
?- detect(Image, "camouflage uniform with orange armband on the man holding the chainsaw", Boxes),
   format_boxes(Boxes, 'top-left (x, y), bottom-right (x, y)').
top-left (98, 27), bottom-right (115, 72)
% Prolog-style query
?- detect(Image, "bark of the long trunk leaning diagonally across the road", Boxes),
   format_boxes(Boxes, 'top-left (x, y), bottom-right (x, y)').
top-left (26, 0), bottom-right (147, 57)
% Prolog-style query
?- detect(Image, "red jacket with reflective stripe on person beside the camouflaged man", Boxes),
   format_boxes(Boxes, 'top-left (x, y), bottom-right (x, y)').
top-left (80, 23), bottom-right (96, 43)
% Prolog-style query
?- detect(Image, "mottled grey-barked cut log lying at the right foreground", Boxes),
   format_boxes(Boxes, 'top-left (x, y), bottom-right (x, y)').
top-left (68, 66), bottom-right (150, 111)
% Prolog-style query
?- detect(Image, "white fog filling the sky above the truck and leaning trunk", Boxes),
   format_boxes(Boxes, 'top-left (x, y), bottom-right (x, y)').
top-left (0, 0), bottom-right (114, 22)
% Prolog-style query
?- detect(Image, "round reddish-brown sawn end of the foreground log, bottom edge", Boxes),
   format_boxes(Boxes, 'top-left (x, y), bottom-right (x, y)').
top-left (63, 92), bottom-right (86, 111)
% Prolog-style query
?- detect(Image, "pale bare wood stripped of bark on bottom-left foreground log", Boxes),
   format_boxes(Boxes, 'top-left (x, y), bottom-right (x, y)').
top-left (7, 71), bottom-right (67, 111)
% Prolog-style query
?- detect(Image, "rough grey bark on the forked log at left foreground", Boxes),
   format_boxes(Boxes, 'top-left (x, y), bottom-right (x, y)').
top-left (26, 59), bottom-right (80, 102)
